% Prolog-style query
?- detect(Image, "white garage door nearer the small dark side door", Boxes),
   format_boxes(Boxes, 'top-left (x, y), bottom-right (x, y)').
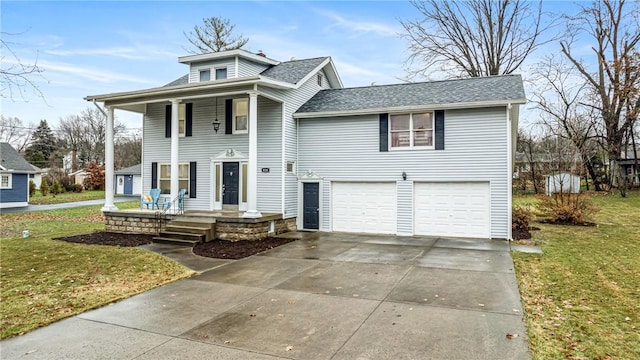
top-left (331, 182), bottom-right (397, 234)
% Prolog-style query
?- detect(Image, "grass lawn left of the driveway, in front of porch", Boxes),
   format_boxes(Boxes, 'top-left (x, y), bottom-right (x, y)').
top-left (0, 201), bottom-right (193, 338)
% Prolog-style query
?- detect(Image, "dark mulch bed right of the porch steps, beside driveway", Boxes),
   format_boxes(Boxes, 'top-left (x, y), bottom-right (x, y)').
top-left (193, 237), bottom-right (295, 259)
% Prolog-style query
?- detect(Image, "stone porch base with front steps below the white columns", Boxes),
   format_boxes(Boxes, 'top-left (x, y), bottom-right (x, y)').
top-left (103, 209), bottom-right (296, 246)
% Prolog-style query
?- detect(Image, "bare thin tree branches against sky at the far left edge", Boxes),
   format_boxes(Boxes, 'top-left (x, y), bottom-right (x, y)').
top-left (0, 31), bottom-right (44, 100)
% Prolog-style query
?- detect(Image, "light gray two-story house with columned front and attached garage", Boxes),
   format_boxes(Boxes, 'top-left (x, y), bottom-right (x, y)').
top-left (85, 50), bottom-right (525, 242)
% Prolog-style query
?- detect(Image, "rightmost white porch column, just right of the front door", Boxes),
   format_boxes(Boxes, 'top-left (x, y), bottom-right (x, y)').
top-left (243, 92), bottom-right (262, 218)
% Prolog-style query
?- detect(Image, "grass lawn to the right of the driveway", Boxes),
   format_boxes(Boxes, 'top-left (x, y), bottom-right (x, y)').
top-left (513, 191), bottom-right (640, 359)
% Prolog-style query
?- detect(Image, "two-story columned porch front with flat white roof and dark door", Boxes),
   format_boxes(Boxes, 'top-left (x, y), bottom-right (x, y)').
top-left (87, 80), bottom-right (284, 219)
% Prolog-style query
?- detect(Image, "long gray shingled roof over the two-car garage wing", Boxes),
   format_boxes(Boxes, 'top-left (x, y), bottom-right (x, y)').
top-left (296, 75), bottom-right (525, 113)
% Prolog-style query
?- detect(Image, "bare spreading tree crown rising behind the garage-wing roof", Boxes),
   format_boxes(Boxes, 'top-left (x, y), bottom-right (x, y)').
top-left (401, 0), bottom-right (551, 77)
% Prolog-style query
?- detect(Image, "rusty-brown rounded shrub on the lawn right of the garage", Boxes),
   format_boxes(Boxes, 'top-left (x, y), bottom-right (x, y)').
top-left (538, 193), bottom-right (599, 225)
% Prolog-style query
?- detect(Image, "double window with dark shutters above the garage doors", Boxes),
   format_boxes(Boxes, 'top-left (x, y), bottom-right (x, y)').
top-left (389, 112), bottom-right (433, 149)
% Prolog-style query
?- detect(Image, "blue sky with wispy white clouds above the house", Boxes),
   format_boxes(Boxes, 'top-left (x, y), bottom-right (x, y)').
top-left (0, 0), bottom-right (573, 133)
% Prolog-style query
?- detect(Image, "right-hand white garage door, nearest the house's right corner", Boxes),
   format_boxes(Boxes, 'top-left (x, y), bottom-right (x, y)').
top-left (414, 182), bottom-right (491, 238)
